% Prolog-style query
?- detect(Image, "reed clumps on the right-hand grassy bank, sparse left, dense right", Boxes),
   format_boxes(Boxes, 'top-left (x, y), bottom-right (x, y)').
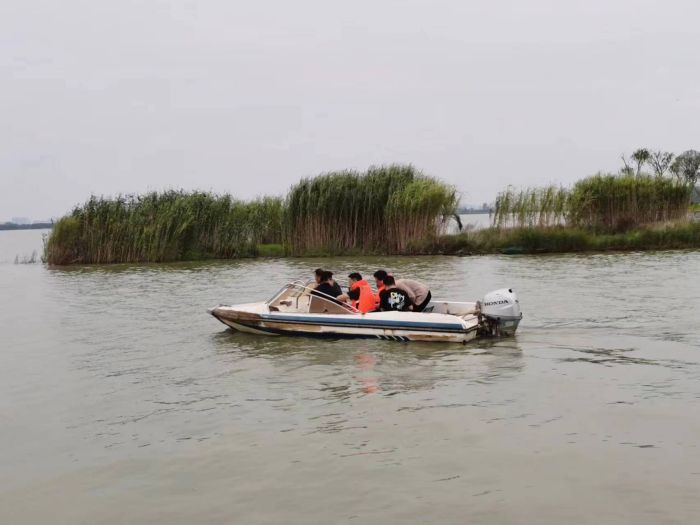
top-left (493, 173), bottom-right (691, 232)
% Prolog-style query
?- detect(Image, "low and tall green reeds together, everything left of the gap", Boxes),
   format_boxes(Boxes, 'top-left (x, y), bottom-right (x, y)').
top-left (44, 165), bottom-right (457, 265)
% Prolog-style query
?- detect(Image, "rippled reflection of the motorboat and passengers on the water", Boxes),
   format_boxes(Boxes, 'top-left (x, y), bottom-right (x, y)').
top-left (212, 329), bottom-right (524, 399)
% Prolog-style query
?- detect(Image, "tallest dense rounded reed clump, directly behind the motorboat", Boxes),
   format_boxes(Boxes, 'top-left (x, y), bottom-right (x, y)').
top-left (285, 165), bottom-right (457, 255)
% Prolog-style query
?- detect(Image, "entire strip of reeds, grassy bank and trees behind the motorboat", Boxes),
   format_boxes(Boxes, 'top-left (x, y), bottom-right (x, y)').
top-left (44, 149), bottom-right (700, 265)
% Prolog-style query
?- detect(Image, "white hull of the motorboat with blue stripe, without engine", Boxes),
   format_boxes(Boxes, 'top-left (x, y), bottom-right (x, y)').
top-left (210, 304), bottom-right (479, 343)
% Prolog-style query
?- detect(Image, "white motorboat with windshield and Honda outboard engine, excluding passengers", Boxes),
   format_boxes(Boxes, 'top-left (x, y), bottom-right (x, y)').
top-left (209, 282), bottom-right (522, 343)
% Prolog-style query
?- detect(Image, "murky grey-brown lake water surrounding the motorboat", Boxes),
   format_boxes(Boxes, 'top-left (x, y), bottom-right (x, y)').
top-left (0, 231), bottom-right (700, 524)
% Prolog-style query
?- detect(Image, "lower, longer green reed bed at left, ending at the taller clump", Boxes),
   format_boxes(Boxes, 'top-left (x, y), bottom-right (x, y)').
top-left (44, 191), bottom-right (283, 265)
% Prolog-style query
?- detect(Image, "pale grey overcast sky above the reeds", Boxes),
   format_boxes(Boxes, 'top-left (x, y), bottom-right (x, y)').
top-left (0, 0), bottom-right (700, 221)
